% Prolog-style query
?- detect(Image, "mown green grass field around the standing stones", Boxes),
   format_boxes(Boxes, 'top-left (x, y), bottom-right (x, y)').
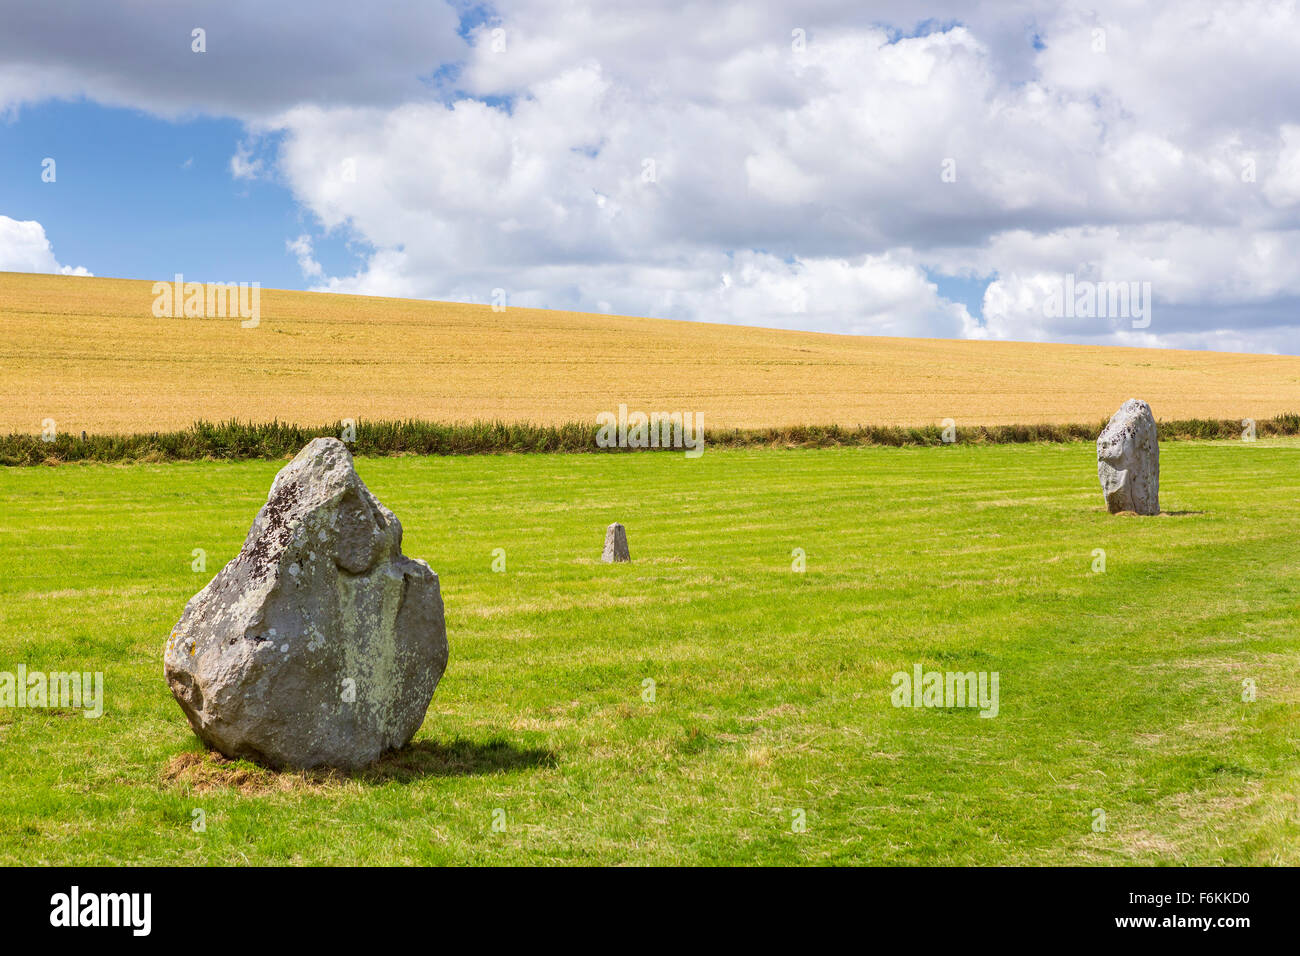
top-left (0, 440), bottom-right (1300, 864)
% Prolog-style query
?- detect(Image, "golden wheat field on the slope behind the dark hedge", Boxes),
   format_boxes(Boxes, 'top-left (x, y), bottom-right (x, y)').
top-left (0, 273), bottom-right (1300, 433)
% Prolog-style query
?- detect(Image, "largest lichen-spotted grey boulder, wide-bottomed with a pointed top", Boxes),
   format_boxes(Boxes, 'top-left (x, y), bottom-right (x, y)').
top-left (164, 438), bottom-right (447, 770)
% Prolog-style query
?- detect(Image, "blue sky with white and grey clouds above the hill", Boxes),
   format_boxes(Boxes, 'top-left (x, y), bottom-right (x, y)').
top-left (0, 0), bottom-right (1300, 354)
